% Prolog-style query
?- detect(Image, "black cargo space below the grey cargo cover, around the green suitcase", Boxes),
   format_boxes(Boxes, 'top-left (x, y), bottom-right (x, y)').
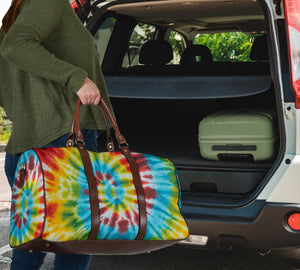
top-left (100, 78), bottom-right (279, 200)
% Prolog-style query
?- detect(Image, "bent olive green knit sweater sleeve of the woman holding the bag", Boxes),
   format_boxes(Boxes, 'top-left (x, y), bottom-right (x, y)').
top-left (0, 0), bottom-right (87, 93)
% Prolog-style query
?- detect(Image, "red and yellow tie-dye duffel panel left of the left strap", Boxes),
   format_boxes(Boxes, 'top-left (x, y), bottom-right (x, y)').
top-left (36, 147), bottom-right (91, 242)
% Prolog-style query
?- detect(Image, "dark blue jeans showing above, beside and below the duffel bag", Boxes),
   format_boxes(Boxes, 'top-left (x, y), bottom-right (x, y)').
top-left (5, 130), bottom-right (97, 270)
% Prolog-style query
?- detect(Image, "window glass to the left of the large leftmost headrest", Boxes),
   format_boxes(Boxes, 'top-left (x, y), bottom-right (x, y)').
top-left (122, 23), bottom-right (156, 68)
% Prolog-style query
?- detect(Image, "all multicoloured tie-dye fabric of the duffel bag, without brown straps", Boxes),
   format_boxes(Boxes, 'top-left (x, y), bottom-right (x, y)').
top-left (10, 147), bottom-right (188, 246)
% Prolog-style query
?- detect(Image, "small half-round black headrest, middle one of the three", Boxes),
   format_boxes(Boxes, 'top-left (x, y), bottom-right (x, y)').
top-left (180, 45), bottom-right (213, 65)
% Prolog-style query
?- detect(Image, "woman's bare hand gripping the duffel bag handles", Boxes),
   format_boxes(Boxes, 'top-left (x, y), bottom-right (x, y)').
top-left (76, 78), bottom-right (100, 105)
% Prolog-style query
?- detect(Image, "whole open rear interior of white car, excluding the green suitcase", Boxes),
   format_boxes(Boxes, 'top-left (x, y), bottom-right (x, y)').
top-left (92, 0), bottom-right (282, 204)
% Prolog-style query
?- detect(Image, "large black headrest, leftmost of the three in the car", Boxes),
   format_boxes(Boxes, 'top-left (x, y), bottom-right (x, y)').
top-left (139, 40), bottom-right (173, 65)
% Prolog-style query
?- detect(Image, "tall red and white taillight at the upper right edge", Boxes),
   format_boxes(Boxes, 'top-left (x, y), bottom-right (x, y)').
top-left (284, 0), bottom-right (300, 109)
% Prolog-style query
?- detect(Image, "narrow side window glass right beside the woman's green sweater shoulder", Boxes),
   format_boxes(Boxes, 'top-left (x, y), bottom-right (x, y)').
top-left (94, 17), bottom-right (116, 64)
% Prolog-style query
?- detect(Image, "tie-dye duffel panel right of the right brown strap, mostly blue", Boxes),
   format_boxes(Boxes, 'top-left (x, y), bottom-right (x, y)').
top-left (132, 153), bottom-right (189, 240)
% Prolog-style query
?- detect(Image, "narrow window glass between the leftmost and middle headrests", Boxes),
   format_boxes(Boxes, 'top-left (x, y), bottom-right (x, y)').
top-left (165, 30), bottom-right (186, 64)
